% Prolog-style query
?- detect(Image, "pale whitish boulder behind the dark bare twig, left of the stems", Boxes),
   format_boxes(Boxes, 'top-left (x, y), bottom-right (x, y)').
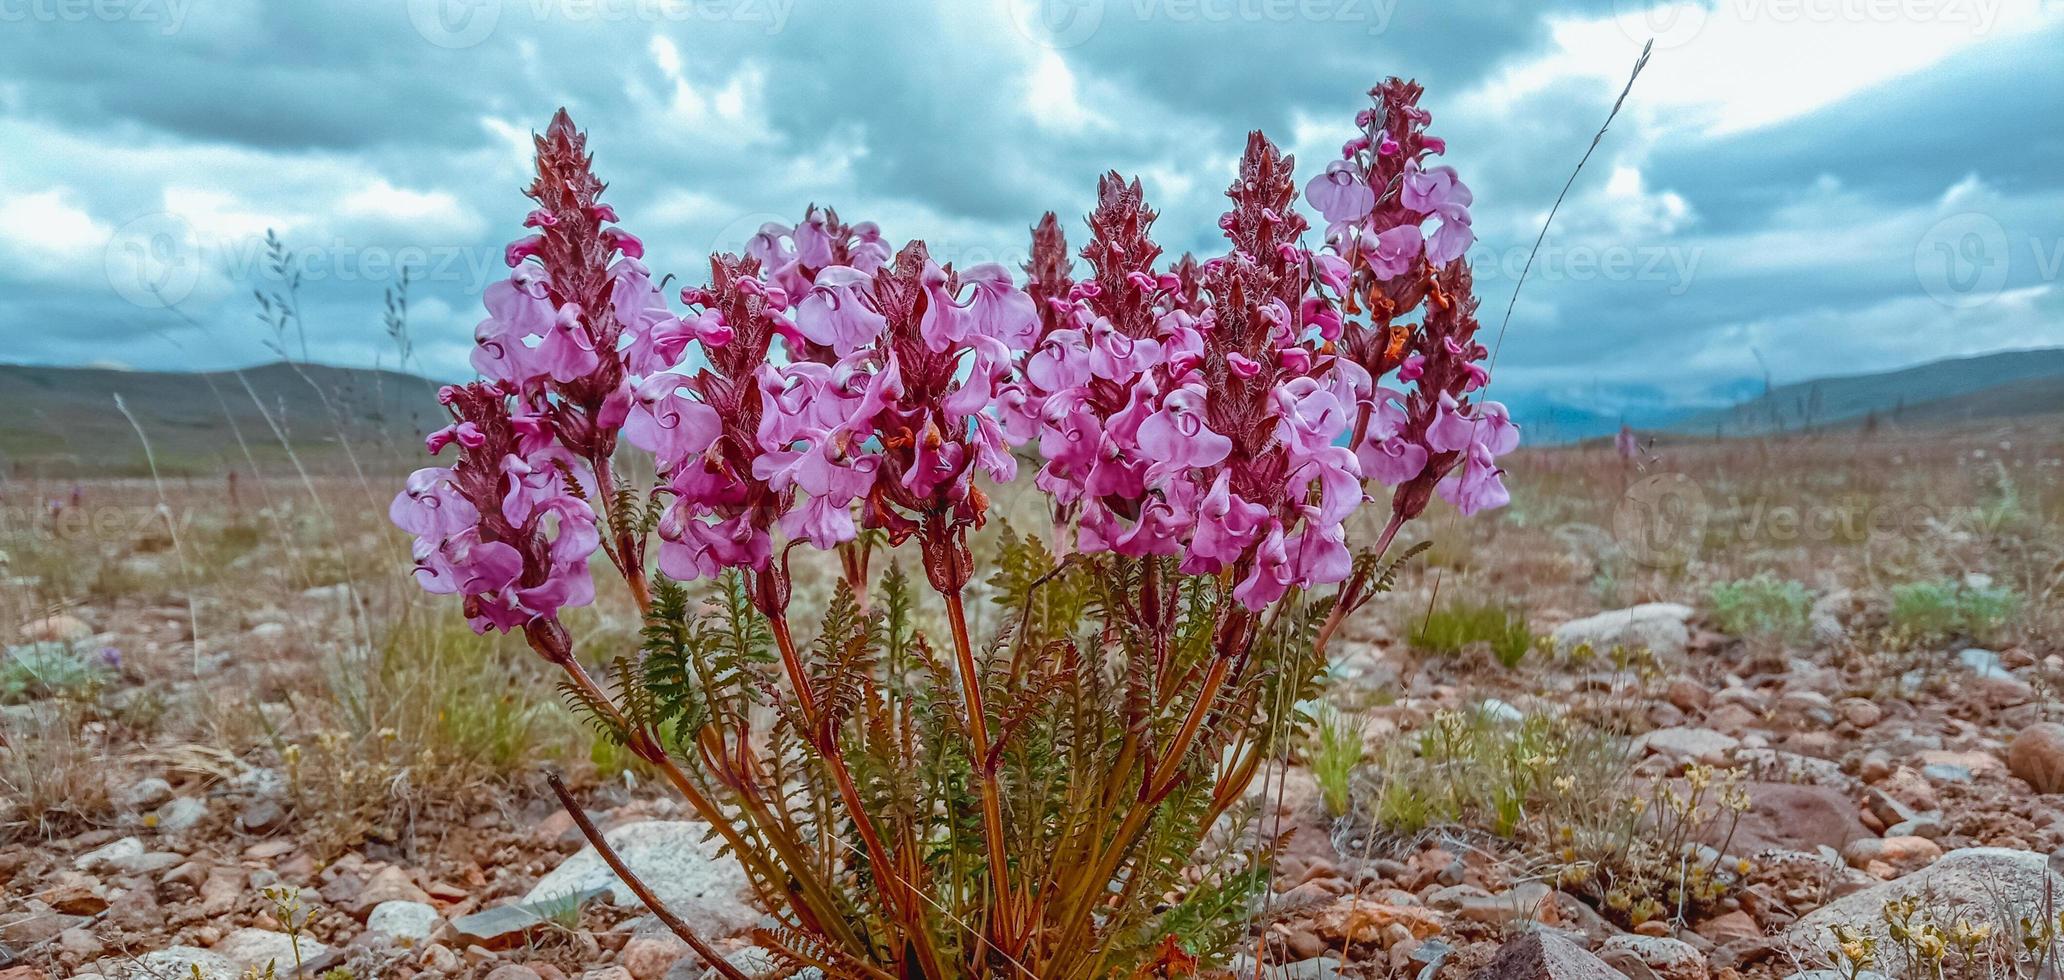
top-left (524, 821), bottom-right (760, 937)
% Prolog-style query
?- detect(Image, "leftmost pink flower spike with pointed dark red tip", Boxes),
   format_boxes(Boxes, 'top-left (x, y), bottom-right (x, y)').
top-left (390, 109), bottom-right (668, 631)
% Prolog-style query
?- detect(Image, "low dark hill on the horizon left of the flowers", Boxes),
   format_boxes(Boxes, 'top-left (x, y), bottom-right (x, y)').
top-left (0, 363), bottom-right (446, 477)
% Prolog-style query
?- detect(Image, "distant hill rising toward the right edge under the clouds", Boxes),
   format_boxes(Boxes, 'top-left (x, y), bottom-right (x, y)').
top-left (1668, 349), bottom-right (2064, 435)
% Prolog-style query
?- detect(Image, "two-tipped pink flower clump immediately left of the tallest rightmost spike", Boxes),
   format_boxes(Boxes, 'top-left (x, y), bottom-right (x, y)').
top-left (1003, 134), bottom-right (1370, 609)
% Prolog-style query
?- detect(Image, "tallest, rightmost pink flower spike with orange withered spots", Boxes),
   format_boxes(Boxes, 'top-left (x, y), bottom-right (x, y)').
top-left (1304, 78), bottom-right (1519, 520)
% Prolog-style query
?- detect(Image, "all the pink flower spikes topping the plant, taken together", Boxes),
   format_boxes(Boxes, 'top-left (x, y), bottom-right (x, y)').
top-left (394, 88), bottom-right (1517, 629)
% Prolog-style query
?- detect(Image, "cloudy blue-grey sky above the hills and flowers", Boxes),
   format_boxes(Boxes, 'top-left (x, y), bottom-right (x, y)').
top-left (0, 0), bottom-right (2064, 429)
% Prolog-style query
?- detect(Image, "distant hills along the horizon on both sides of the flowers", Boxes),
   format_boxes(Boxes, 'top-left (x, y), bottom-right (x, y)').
top-left (0, 349), bottom-right (2064, 477)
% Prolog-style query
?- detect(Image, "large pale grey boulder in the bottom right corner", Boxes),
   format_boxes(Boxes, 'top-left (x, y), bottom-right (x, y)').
top-left (1783, 848), bottom-right (2064, 957)
